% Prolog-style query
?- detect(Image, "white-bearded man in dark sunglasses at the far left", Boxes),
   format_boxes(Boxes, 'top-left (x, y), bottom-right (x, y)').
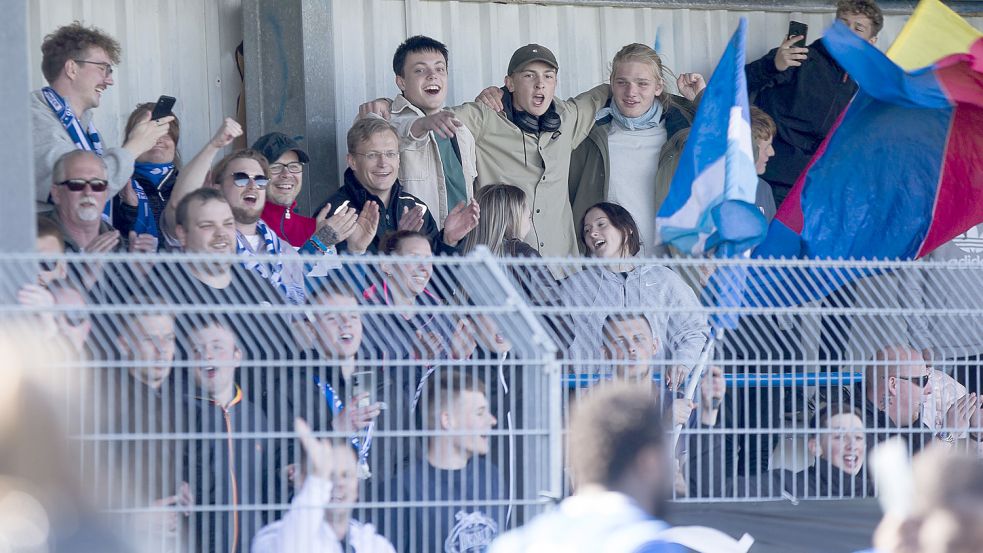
top-left (51, 150), bottom-right (157, 253)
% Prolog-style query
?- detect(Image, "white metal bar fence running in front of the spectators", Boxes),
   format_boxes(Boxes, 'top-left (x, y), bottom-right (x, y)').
top-left (0, 252), bottom-right (983, 551)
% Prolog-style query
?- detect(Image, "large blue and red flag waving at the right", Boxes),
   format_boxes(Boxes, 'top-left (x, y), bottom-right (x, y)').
top-left (754, 22), bottom-right (983, 305)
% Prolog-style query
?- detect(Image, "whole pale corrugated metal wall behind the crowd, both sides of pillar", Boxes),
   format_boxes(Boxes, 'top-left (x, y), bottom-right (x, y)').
top-left (30, 0), bottom-right (983, 190)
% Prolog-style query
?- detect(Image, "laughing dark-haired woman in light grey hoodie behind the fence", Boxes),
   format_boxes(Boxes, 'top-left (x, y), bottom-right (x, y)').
top-left (560, 202), bottom-right (709, 388)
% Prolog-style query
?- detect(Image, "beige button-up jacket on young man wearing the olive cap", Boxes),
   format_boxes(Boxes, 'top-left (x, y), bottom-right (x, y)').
top-left (451, 84), bottom-right (610, 256)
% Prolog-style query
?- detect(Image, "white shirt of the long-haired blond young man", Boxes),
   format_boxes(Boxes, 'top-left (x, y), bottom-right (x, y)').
top-left (607, 122), bottom-right (667, 254)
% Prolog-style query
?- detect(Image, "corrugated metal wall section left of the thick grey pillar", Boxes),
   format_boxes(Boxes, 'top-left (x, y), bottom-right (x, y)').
top-left (28, 0), bottom-right (242, 159)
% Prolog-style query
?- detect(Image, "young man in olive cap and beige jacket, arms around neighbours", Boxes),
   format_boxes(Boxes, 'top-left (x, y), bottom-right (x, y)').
top-left (363, 44), bottom-right (610, 262)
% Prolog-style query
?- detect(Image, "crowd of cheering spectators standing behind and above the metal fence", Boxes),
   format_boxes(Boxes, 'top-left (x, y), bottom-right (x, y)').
top-left (13, 0), bottom-right (983, 553)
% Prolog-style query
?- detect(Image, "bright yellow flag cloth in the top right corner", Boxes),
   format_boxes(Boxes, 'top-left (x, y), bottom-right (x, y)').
top-left (887, 0), bottom-right (983, 71)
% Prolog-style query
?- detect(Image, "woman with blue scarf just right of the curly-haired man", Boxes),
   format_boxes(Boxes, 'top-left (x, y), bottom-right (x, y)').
top-left (113, 102), bottom-right (181, 244)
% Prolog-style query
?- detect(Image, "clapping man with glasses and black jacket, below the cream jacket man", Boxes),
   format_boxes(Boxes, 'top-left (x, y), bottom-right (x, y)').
top-left (321, 117), bottom-right (479, 254)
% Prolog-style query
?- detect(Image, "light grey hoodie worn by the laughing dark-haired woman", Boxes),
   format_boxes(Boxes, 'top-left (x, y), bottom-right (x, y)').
top-left (560, 265), bottom-right (709, 368)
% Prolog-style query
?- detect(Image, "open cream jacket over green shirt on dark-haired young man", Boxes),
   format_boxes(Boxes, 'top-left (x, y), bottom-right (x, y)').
top-left (390, 94), bottom-right (478, 228)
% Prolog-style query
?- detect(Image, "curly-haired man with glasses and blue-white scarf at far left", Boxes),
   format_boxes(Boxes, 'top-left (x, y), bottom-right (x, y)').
top-left (31, 21), bottom-right (173, 202)
